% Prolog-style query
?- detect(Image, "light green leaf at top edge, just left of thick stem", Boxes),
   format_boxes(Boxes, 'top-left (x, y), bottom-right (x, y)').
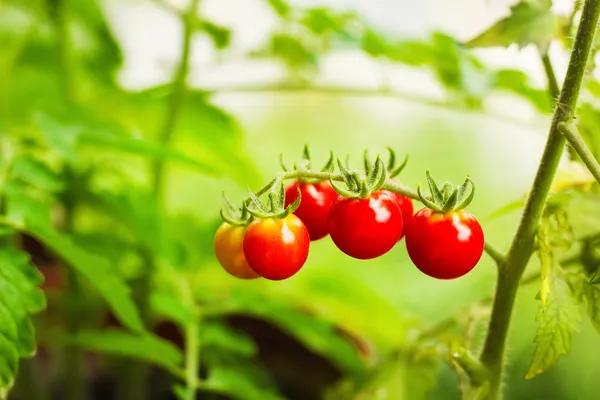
top-left (465, 0), bottom-right (555, 52)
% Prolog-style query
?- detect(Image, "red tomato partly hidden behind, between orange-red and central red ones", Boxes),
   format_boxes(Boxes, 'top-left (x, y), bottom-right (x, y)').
top-left (285, 181), bottom-right (338, 241)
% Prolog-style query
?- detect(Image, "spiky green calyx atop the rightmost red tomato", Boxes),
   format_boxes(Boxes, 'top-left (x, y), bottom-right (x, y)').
top-left (417, 170), bottom-right (475, 213)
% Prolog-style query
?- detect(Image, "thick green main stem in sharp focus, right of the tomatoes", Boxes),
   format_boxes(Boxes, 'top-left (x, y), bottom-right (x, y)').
top-left (480, 0), bottom-right (600, 400)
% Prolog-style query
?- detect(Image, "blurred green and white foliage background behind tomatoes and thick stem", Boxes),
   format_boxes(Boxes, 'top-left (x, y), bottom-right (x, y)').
top-left (0, 0), bottom-right (600, 400)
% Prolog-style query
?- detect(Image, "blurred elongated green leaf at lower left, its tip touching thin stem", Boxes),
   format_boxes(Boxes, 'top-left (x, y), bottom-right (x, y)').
top-left (69, 329), bottom-right (183, 371)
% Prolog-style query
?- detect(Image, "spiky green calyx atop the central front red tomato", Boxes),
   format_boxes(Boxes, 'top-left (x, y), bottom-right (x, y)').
top-left (329, 155), bottom-right (387, 199)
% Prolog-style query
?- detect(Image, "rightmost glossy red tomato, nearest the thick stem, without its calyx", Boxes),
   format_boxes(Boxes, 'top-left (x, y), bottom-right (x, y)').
top-left (406, 208), bottom-right (484, 279)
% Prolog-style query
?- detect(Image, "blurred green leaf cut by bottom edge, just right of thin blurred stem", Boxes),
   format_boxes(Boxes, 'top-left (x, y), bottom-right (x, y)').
top-left (204, 367), bottom-right (283, 400)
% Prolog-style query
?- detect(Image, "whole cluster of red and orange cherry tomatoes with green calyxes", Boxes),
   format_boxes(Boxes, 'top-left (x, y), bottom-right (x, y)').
top-left (214, 150), bottom-right (484, 280)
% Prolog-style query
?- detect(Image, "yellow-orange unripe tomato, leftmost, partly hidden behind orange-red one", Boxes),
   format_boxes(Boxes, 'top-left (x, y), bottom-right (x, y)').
top-left (214, 222), bottom-right (259, 279)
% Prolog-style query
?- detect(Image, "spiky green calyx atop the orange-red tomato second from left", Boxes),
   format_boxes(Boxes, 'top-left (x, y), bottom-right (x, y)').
top-left (244, 180), bottom-right (302, 219)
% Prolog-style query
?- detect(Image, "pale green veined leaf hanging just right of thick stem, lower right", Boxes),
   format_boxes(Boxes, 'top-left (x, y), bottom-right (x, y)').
top-left (525, 225), bottom-right (580, 379)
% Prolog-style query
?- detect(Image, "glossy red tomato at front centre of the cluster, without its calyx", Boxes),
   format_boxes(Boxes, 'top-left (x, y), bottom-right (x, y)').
top-left (327, 191), bottom-right (403, 260)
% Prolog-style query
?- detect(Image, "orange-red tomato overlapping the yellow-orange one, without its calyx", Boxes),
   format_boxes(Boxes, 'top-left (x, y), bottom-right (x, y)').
top-left (244, 214), bottom-right (310, 281)
